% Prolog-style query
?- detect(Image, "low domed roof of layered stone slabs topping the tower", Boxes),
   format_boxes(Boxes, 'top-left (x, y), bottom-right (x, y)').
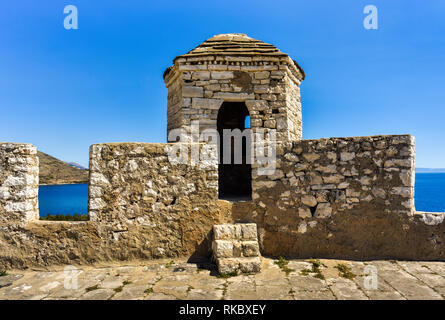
top-left (164, 33), bottom-right (305, 80)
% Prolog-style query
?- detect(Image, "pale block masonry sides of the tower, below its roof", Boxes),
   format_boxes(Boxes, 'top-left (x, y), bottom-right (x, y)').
top-left (165, 56), bottom-right (302, 142)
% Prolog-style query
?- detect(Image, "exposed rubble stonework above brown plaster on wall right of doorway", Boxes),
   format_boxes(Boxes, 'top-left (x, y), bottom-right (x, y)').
top-left (277, 136), bottom-right (415, 219)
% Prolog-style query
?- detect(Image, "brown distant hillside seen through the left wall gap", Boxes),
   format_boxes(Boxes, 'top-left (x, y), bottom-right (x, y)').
top-left (37, 151), bottom-right (88, 184)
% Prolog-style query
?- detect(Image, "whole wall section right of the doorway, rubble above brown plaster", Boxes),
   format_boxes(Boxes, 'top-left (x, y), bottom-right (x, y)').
top-left (235, 135), bottom-right (445, 259)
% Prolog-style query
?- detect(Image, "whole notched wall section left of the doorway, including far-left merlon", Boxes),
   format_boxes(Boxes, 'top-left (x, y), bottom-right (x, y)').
top-left (0, 143), bottom-right (231, 269)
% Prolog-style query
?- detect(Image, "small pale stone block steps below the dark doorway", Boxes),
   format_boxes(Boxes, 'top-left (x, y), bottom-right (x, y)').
top-left (212, 223), bottom-right (261, 274)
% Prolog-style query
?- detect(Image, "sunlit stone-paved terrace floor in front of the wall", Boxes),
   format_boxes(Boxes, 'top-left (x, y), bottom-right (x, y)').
top-left (0, 258), bottom-right (445, 300)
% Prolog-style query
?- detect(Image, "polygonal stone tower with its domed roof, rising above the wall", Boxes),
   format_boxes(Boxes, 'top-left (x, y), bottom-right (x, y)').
top-left (164, 33), bottom-right (305, 142)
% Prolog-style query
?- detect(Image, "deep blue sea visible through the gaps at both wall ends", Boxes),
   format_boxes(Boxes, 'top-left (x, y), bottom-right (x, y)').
top-left (39, 173), bottom-right (445, 217)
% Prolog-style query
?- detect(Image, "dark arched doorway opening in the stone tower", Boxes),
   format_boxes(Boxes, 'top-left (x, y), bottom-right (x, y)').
top-left (217, 102), bottom-right (252, 200)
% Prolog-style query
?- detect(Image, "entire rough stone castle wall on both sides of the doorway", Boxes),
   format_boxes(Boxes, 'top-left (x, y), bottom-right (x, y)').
top-left (0, 135), bottom-right (445, 268)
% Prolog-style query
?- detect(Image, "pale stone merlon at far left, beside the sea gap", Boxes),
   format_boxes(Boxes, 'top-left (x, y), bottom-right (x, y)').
top-left (0, 143), bottom-right (39, 229)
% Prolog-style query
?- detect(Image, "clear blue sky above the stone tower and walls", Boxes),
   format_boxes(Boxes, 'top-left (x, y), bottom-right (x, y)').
top-left (0, 0), bottom-right (445, 168)
